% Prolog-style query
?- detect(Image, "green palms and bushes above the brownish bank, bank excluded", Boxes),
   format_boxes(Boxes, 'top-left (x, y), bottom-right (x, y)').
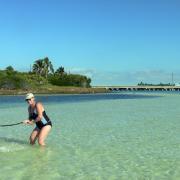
top-left (0, 57), bottom-right (91, 89)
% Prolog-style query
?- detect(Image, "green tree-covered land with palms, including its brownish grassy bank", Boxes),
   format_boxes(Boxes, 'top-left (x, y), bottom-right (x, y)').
top-left (0, 57), bottom-right (104, 94)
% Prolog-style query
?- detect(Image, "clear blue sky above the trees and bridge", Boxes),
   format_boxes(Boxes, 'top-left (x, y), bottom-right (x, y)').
top-left (0, 0), bottom-right (180, 85)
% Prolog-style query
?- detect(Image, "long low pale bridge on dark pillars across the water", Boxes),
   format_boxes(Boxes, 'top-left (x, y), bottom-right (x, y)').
top-left (92, 86), bottom-right (180, 91)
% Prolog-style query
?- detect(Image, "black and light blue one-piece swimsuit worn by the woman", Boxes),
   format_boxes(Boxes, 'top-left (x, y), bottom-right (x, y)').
top-left (29, 106), bottom-right (52, 129)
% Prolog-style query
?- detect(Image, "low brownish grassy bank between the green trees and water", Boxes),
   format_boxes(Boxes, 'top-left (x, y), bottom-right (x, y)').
top-left (0, 87), bottom-right (109, 95)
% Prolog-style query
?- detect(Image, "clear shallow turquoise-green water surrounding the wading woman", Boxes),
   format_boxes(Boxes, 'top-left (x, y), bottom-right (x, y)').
top-left (0, 92), bottom-right (180, 180)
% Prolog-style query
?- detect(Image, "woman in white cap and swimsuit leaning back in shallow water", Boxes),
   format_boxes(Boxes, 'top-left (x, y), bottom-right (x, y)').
top-left (23, 93), bottom-right (52, 146)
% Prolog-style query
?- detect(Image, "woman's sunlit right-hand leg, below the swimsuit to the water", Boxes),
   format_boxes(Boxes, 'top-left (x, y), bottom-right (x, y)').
top-left (38, 125), bottom-right (51, 146)
